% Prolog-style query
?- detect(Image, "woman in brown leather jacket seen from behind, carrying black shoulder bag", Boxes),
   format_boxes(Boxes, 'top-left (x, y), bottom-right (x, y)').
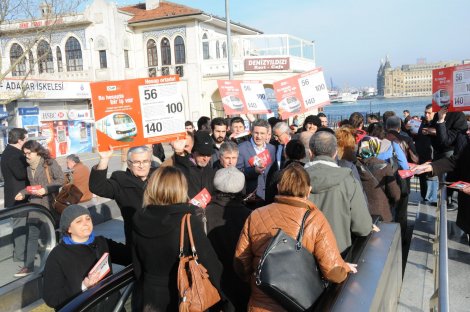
top-left (234, 164), bottom-right (357, 311)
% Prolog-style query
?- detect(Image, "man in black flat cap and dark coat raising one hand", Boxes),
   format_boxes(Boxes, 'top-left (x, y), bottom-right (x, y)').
top-left (173, 131), bottom-right (215, 198)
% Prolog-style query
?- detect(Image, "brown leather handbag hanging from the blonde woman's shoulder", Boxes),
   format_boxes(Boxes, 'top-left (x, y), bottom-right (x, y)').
top-left (178, 213), bottom-right (220, 312)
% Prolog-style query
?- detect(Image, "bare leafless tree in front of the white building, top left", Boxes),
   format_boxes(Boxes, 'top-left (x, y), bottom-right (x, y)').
top-left (0, 0), bottom-right (85, 105)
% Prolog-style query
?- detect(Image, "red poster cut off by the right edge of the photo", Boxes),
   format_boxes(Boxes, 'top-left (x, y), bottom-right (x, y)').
top-left (432, 64), bottom-right (470, 112)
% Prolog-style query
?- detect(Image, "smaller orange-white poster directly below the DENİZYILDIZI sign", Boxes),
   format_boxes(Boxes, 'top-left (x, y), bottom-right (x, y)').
top-left (217, 80), bottom-right (271, 115)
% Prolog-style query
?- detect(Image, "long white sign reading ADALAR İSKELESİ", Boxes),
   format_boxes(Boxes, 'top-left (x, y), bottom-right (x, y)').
top-left (0, 78), bottom-right (91, 99)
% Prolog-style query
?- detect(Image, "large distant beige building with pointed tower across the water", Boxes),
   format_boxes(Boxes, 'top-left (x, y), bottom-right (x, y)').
top-left (377, 58), bottom-right (462, 97)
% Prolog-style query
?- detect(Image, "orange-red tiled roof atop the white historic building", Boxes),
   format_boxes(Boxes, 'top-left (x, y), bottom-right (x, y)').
top-left (119, 1), bottom-right (203, 23)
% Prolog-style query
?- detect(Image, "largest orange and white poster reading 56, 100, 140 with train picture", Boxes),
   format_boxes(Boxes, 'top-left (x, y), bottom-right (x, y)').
top-left (90, 75), bottom-right (186, 151)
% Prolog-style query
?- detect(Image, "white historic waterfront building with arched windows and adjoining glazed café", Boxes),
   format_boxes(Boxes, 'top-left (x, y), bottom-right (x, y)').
top-left (0, 0), bottom-right (315, 152)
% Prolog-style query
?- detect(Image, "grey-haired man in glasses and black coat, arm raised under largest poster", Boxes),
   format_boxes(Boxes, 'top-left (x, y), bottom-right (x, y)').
top-left (89, 146), bottom-right (155, 246)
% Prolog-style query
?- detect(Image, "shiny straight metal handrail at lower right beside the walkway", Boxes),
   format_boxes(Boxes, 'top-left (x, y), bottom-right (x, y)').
top-left (438, 177), bottom-right (449, 312)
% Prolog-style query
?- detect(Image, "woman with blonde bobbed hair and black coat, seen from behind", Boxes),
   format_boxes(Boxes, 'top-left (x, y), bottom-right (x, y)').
top-left (132, 167), bottom-right (222, 311)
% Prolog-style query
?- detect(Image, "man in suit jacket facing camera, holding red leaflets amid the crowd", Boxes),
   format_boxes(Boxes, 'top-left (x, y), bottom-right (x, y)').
top-left (237, 119), bottom-right (277, 201)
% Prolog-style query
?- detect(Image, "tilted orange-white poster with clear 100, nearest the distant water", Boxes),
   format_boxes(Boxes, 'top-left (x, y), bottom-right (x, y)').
top-left (273, 68), bottom-right (330, 119)
